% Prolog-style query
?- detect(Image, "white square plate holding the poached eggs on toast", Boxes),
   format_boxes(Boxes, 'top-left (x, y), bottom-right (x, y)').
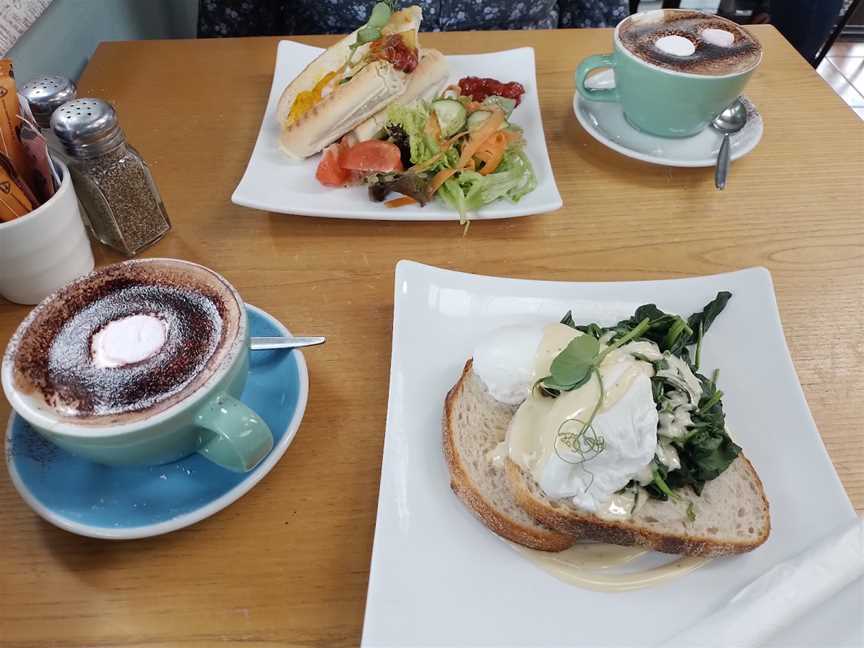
top-left (363, 261), bottom-right (864, 647)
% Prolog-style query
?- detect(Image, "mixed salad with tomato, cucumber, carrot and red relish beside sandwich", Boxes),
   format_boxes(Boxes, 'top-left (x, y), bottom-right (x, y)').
top-left (315, 77), bottom-right (537, 223)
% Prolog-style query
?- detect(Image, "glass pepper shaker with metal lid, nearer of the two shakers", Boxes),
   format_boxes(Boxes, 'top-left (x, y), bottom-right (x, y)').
top-left (51, 99), bottom-right (171, 257)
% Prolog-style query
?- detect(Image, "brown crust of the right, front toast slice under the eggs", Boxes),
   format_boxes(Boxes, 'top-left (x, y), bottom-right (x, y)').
top-left (506, 454), bottom-right (771, 556)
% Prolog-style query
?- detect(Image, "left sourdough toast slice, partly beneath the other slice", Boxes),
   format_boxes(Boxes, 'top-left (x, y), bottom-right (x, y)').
top-left (443, 360), bottom-right (575, 551)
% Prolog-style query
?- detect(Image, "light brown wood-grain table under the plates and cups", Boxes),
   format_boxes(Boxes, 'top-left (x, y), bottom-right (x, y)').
top-left (0, 27), bottom-right (864, 648)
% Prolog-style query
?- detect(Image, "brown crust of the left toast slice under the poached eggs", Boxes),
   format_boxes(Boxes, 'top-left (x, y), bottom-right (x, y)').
top-left (443, 360), bottom-right (575, 551)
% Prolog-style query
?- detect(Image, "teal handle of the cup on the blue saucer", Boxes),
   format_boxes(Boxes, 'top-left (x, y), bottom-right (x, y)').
top-left (195, 393), bottom-right (273, 472)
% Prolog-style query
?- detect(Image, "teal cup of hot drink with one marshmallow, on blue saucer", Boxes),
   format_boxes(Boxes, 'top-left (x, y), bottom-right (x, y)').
top-left (2, 259), bottom-right (273, 472)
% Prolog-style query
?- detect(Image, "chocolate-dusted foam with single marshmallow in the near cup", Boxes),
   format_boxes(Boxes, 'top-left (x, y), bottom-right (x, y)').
top-left (7, 259), bottom-right (240, 425)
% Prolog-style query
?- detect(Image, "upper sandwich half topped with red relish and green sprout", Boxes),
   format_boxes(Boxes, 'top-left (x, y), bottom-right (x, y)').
top-left (276, 2), bottom-right (422, 158)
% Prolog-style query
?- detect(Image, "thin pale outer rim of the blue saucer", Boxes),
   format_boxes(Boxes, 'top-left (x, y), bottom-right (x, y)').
top-left (4, 302), bottom-right (309, 540)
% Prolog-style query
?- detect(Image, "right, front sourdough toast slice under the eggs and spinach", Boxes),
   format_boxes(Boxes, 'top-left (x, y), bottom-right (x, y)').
top-left (506, 454), bottom-right (771, 556)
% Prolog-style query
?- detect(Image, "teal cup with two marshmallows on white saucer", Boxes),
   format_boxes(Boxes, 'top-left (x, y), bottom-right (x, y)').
top-left (576, 9), bottom-right (762, 137)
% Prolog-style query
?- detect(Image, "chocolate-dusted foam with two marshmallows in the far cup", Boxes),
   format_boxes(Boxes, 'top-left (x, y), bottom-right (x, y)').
top-left (618, 9), bottom-right (762, 76)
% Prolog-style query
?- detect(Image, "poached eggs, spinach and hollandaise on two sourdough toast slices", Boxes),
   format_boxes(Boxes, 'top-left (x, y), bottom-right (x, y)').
top-left (443, 293), bottom-right (771, 556)
